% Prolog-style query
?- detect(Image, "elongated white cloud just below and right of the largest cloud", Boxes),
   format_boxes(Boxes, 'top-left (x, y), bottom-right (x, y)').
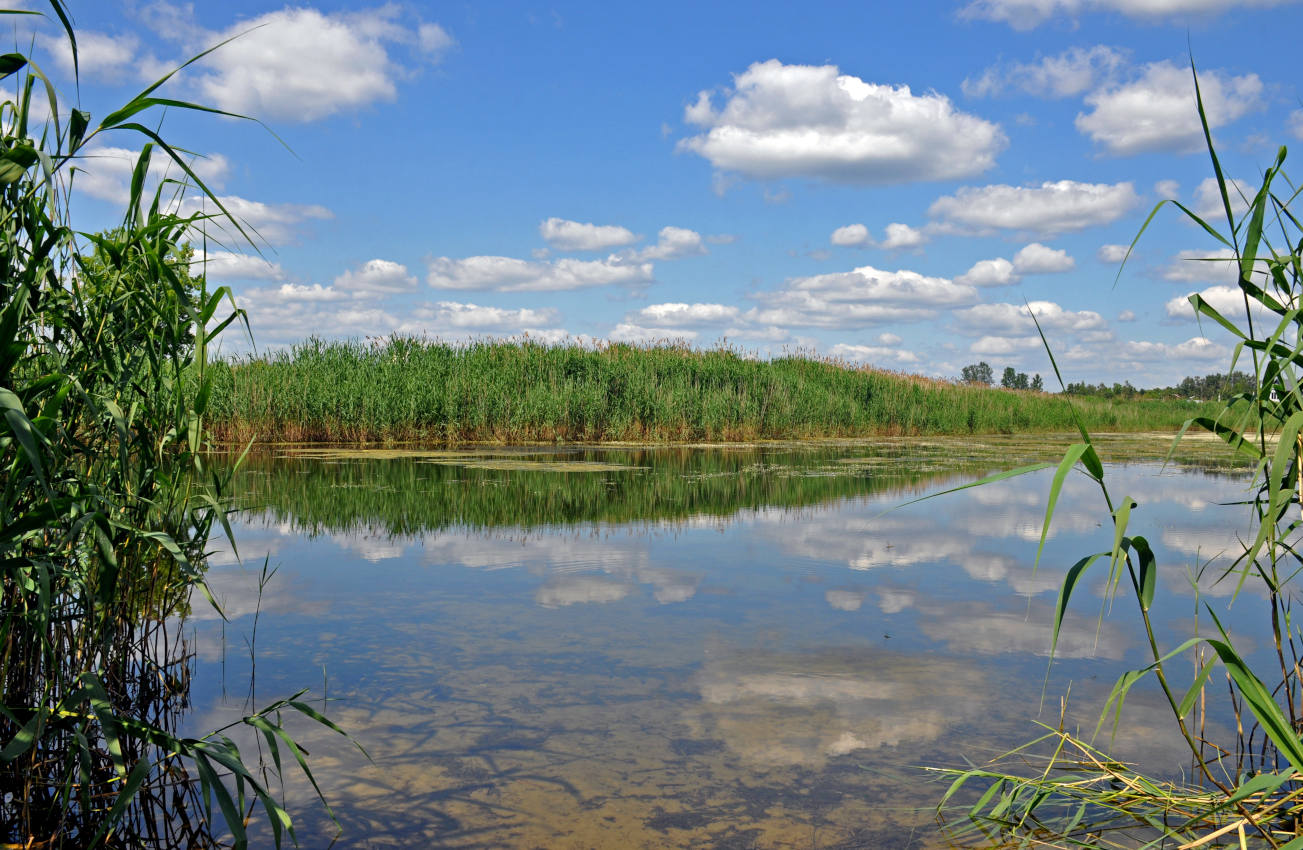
top-left (928, 180), bottom-right (1140, 235)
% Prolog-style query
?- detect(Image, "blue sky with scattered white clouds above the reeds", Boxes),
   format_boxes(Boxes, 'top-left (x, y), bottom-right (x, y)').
top-left (10, 0), bottom-right (1303, 388)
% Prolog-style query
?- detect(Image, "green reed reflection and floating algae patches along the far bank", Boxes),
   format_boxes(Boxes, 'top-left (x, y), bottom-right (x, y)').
top-left (232, 434), bottom-right (1243, 535)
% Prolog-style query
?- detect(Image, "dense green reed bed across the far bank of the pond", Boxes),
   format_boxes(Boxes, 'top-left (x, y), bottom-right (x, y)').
top-left (210, 336), bottom-right (1203, 443)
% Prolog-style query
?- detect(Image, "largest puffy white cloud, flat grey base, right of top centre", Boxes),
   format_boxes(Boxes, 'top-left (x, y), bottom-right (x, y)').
top-left (679, 60), bottom-right (1007, 184)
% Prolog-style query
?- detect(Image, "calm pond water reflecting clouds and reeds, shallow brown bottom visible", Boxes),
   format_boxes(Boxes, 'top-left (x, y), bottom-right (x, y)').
top-left (185, 437), bottom-right (1265, 847)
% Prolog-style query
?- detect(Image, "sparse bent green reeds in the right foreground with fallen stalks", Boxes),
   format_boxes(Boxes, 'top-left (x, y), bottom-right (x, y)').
top-left (942, 77), bottom-right (1303, 850)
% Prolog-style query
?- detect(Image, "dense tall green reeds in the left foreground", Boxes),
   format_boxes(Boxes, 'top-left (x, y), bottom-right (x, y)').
top-left (0, 0), bottom-right (346, 847)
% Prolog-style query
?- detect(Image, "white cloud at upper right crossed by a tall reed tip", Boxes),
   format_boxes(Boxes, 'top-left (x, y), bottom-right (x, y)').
top-left (1076, 61), bottom-right (1263, 155)
